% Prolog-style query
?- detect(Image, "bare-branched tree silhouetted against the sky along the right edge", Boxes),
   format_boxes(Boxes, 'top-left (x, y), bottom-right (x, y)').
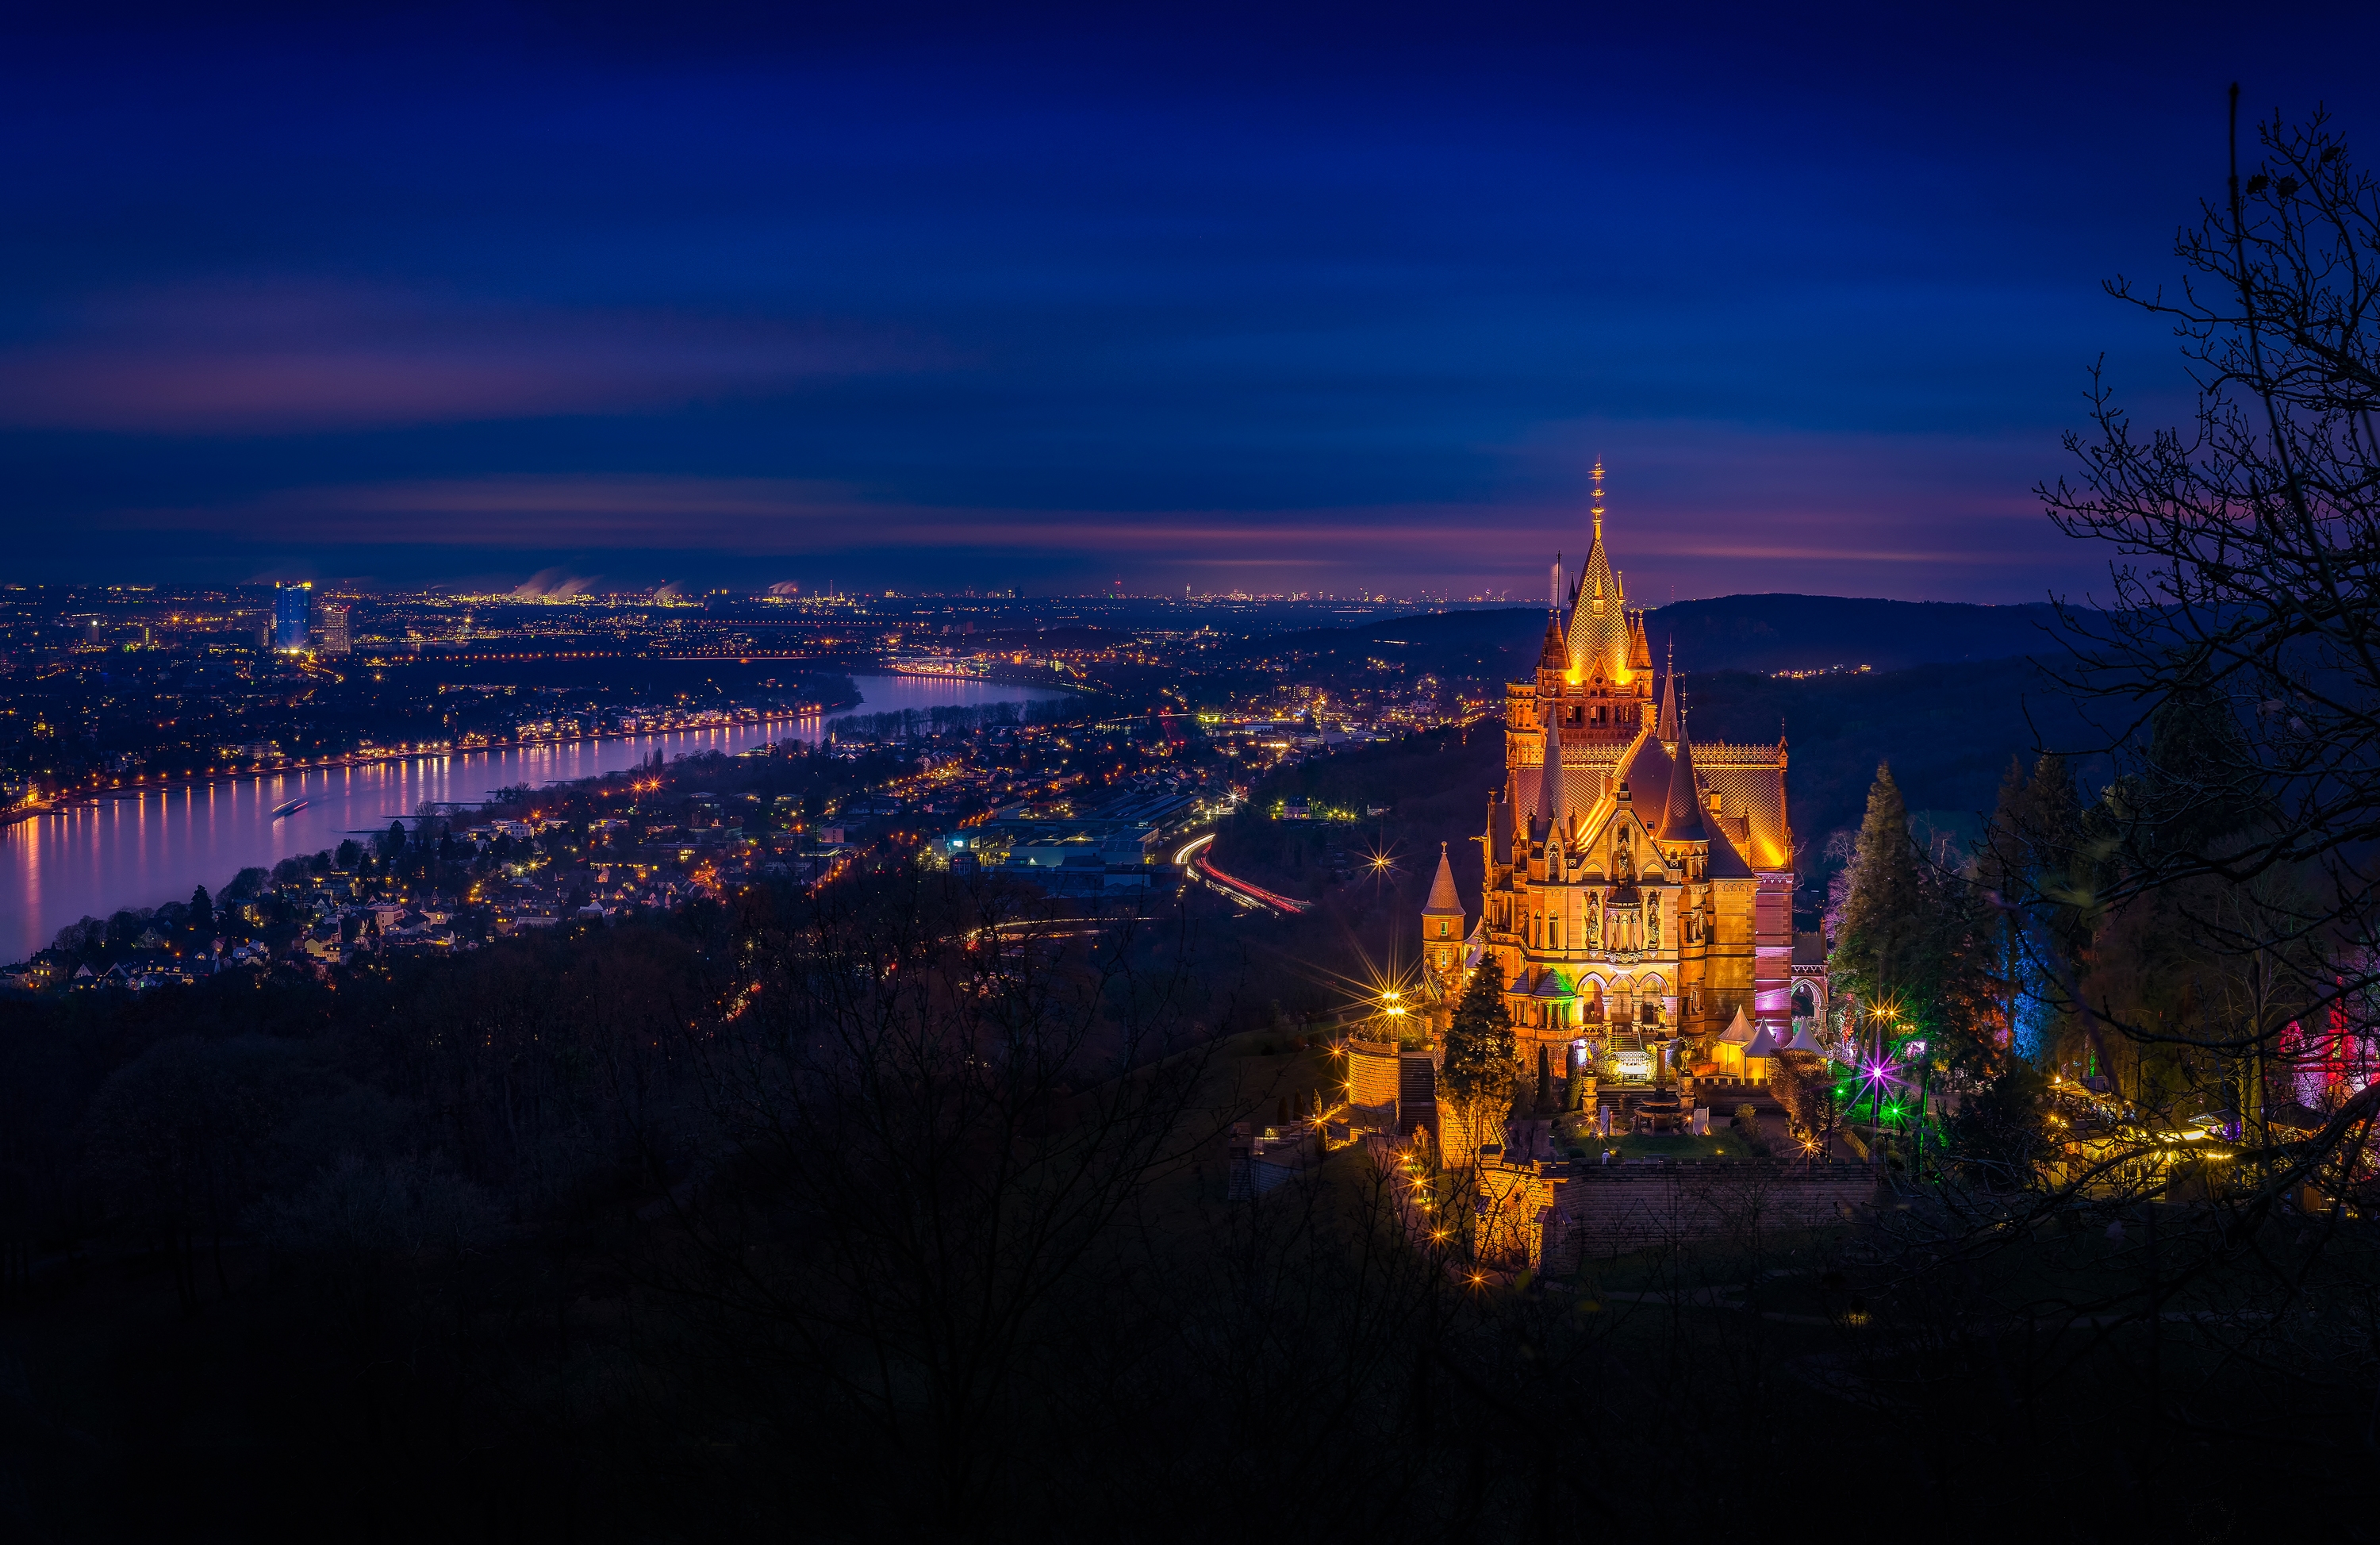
top-left (2040, 99), bottom-right (2380, 1143)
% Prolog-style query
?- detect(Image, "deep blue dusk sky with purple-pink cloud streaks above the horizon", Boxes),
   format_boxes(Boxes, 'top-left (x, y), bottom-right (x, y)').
top-left (0, 5), bottom-right (2380, 602)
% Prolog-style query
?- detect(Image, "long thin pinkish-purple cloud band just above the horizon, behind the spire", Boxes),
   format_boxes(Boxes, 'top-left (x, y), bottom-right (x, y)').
top-left (107, 452), bottom-right (2085, 590)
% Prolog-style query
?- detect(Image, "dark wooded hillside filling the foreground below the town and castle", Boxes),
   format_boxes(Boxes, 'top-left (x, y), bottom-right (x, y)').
top-left (0, 874), bottom-right (2375, 1540)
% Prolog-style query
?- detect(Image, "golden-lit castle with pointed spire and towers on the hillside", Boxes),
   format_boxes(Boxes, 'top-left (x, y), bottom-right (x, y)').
top-left (1421, 462), bottom-right (1795, 1078)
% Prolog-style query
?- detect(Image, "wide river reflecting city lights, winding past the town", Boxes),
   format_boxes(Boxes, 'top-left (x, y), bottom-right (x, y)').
top-left (0, 676), bottom-right (1066, 959)
